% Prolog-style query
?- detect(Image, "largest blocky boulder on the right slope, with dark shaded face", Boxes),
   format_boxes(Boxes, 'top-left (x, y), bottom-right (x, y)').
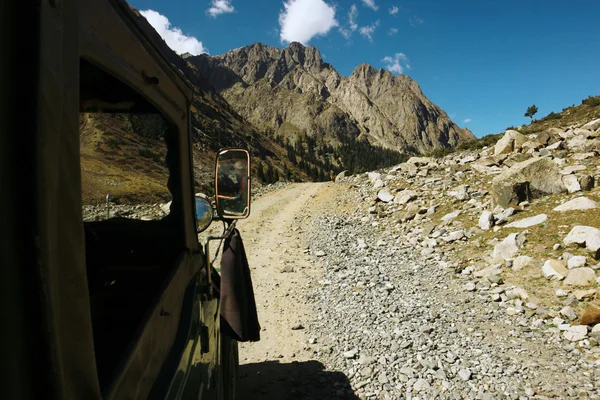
top-left (491, 157), bottom-right (566, 208)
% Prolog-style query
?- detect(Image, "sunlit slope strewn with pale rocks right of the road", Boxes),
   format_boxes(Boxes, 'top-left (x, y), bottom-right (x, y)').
top-left (337, 119), bottom-right (600, 350)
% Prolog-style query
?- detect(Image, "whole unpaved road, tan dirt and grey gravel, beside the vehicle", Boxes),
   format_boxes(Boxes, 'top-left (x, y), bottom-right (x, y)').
top-left (233, 183), bottom-right (600, 399)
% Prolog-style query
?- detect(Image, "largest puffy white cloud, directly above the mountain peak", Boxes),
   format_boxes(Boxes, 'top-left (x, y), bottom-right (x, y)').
top-left (279, 0), bottom-right (338, 44)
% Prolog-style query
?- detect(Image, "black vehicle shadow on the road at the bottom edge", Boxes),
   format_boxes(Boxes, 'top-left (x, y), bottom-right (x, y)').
top-left (237, 361), bottom-right (358, 400)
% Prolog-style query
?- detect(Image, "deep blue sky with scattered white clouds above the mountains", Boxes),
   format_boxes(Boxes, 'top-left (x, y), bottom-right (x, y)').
top-left (130, 0), bottom-right (600, 137)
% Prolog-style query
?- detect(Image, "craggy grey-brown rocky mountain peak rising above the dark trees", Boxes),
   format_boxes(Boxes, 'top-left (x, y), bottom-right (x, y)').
top-left (185, 42), bottom-right (474, 153)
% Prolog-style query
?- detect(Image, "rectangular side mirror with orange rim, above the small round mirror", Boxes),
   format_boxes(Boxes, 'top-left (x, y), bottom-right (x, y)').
top-left (215, 149), bottom-right (250, 219)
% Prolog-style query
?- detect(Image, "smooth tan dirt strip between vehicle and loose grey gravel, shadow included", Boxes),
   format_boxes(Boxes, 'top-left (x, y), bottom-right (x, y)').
top-left (239, 183), bottom-right (356, 400)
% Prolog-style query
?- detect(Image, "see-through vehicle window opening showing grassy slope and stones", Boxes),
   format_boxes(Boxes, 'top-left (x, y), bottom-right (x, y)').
top-left (79, 112), bottom-right (171, 221)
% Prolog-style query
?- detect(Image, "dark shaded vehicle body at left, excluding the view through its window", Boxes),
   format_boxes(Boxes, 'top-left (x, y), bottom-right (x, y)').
top-left (0, 0), bottom-right (237, 400)
